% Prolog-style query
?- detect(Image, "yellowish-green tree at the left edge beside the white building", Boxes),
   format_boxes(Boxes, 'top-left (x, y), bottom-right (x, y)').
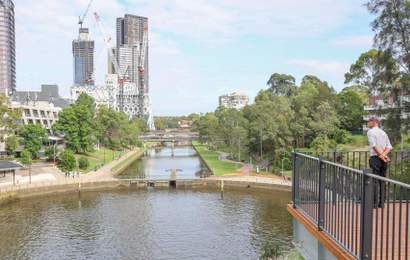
top-left (0, 94), bottom-right (21, 142)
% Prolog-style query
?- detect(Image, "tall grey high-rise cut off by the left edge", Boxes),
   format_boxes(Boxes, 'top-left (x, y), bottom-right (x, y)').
top-left (0, 0), bottom-right (16, 95)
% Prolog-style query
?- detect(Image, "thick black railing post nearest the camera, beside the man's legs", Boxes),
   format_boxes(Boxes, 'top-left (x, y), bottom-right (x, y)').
top-left (360, 169), bottom-right (374, 259)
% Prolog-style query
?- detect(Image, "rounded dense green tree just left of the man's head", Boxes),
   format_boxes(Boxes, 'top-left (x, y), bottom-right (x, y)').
top-left (337, 89), bottom-right (364, 131)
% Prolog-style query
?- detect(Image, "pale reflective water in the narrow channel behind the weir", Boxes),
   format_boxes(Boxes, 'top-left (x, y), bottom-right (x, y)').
top-left (119, 146), bottom-right (209, 180)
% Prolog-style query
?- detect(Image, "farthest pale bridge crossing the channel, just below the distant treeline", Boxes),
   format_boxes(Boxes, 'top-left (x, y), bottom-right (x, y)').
top-left (139, 130), bottom-right (199, 142)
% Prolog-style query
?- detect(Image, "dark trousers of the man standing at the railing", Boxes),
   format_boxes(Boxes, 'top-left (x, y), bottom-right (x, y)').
top-left (369, 156), bottom-right (387, 208)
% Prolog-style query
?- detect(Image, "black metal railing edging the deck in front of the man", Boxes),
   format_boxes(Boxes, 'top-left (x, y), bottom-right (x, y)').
top-left (292, 153), bottom-right (410, 259)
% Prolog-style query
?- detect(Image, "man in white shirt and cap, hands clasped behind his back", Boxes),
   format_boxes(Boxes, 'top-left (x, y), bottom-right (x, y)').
top-left (367, 117), bottom-right (393, 208)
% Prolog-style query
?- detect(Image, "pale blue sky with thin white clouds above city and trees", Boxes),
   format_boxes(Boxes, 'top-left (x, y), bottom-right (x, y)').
top-left (14, 0), bottom-right (373, 116)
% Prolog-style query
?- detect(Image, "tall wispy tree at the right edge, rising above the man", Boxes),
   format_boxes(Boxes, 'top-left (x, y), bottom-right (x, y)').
top-left (367, 0), bottom-right (410, 140)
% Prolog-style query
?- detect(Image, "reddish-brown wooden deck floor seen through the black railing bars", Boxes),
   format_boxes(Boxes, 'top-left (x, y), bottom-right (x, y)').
top-left (288, 201), bottom-right (410, 260)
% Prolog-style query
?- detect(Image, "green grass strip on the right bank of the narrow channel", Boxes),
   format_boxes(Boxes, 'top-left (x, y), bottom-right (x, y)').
top-left (192, 142), bottom-right (241, 176)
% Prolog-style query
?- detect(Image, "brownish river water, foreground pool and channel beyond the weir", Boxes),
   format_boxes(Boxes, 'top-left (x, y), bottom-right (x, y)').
top-left (0, 145), bottom-right (292, 259)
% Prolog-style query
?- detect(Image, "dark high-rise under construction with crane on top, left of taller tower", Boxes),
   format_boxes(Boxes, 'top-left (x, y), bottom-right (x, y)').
top-left (73, 28), bottom-right (94, 86)
